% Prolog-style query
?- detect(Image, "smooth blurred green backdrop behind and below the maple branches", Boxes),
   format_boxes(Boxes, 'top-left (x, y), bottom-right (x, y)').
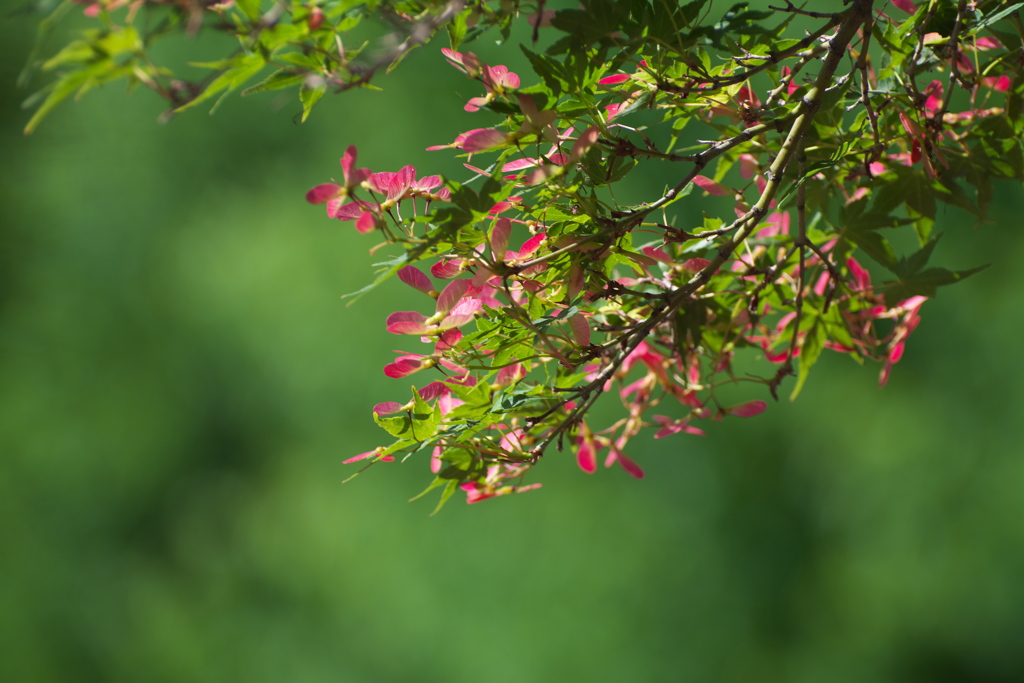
top-left (0, 6), bottom-right (1024, 683)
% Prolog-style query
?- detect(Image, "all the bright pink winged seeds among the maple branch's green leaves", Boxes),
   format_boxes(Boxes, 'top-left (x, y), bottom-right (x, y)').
top-left (307, 33), bottom-right (974, 503)
